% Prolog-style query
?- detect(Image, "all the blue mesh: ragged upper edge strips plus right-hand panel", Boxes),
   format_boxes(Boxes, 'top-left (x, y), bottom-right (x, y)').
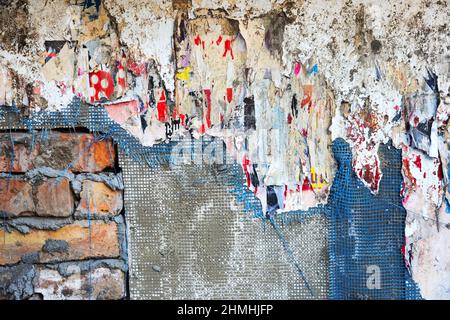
top-left (0, 100), bottom-right (421, 299)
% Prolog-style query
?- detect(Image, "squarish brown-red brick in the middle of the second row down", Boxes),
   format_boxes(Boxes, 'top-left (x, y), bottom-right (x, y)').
top-left (35, 178), bottom-right (75, 217)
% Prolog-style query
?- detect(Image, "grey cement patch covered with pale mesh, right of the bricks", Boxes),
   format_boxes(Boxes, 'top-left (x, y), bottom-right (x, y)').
top-left (119, 153), bottom-right (328, 299)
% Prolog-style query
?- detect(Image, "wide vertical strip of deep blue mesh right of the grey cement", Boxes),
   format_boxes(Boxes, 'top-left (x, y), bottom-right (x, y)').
top-left (327, 139), bottom-right (420, 299)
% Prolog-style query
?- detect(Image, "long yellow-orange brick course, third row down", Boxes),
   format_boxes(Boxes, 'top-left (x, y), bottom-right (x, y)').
top-left (0, 221), bottom-right (120, 265)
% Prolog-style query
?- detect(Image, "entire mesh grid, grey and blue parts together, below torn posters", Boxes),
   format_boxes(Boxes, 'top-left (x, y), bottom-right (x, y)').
top-left (0, 100), bottom-right (420, 299)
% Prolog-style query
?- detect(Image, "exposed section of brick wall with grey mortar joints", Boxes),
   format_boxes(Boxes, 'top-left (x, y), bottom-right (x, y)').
top-left (0, 131), bottom-right (127, 299)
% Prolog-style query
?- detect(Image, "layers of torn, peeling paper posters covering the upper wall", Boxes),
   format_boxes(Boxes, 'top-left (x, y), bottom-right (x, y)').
top-left (0, 0), bottom-right (450, 297)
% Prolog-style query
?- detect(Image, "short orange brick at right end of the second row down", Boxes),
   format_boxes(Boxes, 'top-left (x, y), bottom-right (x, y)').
top-left (77, 180), bottom-right (123, 215)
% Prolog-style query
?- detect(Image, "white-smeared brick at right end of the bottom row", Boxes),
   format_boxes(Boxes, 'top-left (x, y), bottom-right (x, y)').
top-left (34, 265), bottom-right (125, 300)
